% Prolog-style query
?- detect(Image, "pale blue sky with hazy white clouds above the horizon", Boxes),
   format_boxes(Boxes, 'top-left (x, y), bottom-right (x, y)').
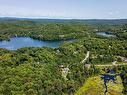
top-left (0, 0), bottom-right (127, 19)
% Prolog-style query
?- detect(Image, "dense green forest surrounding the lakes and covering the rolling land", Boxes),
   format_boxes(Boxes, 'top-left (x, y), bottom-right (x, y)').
top-left (0, 19), bottom-right (127, 95)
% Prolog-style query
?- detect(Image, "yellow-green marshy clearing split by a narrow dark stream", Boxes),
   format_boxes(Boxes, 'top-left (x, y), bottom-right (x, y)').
top-left (75, 76), bottom-right (123, 95)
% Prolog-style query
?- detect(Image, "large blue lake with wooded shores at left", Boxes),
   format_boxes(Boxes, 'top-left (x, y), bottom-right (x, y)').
top-left (0, 37), bottom-right (73, 50)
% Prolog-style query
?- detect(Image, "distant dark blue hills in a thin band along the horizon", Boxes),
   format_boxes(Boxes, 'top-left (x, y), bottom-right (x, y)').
top-left (0, 17), bottom-right (127, 24)
